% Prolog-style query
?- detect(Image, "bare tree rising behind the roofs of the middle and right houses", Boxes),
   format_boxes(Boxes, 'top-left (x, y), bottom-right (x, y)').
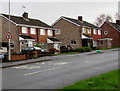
top-left (94, 14), bottom-right (113, 26)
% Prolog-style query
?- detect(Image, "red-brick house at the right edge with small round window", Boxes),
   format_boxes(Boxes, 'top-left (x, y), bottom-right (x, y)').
top-left (101, 20), bottom-right (120, 47)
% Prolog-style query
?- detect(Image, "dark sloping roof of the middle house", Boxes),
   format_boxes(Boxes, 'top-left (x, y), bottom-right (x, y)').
top-left (63, 17), bottom-right (100, 29)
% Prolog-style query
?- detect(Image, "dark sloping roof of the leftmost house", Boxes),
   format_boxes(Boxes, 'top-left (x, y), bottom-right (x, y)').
top-left (2, 14), bottom-right (52, 28)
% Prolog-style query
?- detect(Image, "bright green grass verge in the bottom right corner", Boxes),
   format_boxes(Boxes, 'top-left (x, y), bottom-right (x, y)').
top-left (59, 69), bottom-right (120, 91)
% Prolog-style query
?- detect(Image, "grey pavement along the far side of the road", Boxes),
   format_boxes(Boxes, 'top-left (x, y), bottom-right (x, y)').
top-left (0, 48), bottom-right (118, 68)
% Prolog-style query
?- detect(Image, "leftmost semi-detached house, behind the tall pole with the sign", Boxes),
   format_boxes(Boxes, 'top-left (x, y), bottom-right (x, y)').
top-left (0, 12), bottom-right (60, 52)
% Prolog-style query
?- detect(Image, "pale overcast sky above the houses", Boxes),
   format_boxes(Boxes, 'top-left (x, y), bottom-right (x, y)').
top-left (0, 0), bottom-right (119, 25)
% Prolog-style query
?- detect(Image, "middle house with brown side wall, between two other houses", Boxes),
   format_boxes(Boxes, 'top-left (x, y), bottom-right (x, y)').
top-left (52, 16), bottom-right (102, 49)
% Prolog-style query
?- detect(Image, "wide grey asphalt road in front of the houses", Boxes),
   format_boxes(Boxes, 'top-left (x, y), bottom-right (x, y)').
top-left (2, 51), bottom-right (118, 89)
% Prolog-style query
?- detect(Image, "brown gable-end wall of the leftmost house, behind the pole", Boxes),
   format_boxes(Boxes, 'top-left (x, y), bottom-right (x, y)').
top-left (0, 16), bottom-right (20, 52)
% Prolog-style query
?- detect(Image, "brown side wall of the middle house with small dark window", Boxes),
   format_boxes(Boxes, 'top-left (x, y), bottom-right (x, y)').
top-left (53, 19), bottom-right (82, 49)
